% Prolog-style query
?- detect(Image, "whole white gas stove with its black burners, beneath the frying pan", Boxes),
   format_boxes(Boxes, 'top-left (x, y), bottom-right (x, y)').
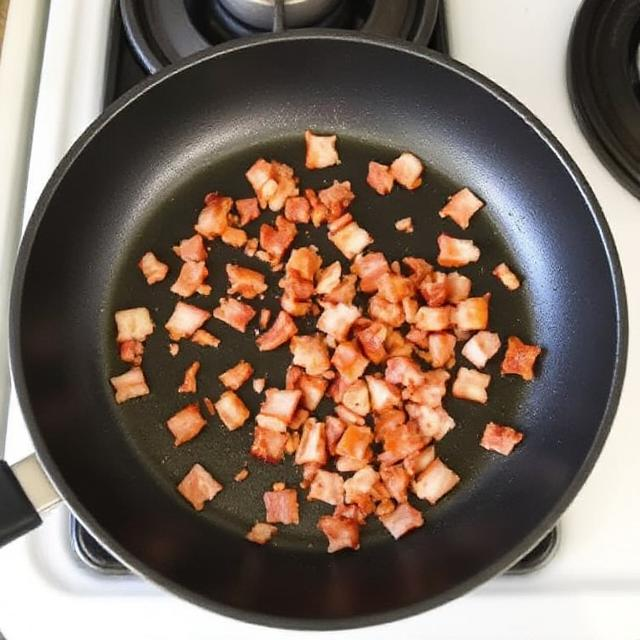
top-left (0, 0), bottom-right (640, 639)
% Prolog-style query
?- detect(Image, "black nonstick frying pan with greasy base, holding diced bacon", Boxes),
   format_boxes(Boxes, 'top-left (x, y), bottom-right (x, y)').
top-left (0, 31), bottom-right (626, 629)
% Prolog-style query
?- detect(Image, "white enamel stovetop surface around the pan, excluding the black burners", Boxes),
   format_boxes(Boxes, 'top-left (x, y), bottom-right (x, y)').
top-left (0, 0), bottom-right (640, 640)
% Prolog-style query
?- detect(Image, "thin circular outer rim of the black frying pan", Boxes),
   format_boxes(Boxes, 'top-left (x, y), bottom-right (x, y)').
top-left (9, 29), bottom-right (628, 630)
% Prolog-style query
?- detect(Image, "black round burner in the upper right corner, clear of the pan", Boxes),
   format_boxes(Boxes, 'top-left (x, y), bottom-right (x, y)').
top-left (567, 0), bottom-right (640, 198)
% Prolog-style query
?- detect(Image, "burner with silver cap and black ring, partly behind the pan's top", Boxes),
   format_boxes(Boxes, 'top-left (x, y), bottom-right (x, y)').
top-left (120, 0), bottom-right (441, 73)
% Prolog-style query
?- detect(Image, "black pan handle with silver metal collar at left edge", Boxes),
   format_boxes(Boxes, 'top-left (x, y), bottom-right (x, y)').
top-left (0, 454), bottom-right (61, 547)
